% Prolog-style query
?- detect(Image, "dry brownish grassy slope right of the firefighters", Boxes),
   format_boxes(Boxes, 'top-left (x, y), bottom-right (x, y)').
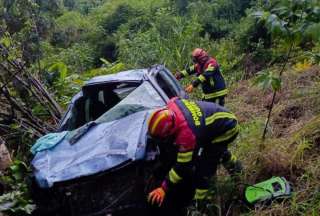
top-left (208, 66), bottom-right (320, 216)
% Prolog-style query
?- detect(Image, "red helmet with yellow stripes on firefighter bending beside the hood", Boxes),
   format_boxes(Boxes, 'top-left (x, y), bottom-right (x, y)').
top-left (148, 108), bottom-right (175, 138)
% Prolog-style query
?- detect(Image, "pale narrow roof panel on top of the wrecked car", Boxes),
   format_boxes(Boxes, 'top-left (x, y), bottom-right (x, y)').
top-left (85, 69), bottom-right (148, 86)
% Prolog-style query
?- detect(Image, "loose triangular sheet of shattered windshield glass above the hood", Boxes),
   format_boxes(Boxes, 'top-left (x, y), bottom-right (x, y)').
top-left (95, 82), bottom-right (165, 123)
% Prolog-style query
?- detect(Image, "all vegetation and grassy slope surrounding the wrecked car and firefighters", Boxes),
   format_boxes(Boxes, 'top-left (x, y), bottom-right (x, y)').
top-left (0, 0), bottom-right (320, 215)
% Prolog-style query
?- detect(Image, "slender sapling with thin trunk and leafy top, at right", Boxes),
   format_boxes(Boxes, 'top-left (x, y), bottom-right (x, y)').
top-left (252, 0), bottom-right (320, 139)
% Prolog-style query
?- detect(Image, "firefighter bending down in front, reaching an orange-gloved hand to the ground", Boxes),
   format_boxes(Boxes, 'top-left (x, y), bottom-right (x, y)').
top-left (148, 98), bottom-right (242, 206)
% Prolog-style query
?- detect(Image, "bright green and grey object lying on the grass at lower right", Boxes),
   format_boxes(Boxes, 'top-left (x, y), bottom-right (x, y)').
top-left (245, 177), bottom-right (291, 205)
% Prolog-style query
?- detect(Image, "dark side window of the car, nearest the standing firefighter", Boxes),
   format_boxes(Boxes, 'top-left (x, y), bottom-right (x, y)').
top-left (156, 70), bottom-right (181, 98)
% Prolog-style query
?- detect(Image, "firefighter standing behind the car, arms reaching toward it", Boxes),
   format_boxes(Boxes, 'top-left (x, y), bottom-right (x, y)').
top-left (175, 48), bottom-right (228, 106)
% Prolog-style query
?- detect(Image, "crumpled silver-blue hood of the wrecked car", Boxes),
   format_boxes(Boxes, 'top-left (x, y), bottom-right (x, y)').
top-left (32, 109), bottom-right (151, 188)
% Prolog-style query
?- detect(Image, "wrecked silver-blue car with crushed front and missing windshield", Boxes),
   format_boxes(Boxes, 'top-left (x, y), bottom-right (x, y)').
top-left (32, 65), bottom-right (187, 216)
